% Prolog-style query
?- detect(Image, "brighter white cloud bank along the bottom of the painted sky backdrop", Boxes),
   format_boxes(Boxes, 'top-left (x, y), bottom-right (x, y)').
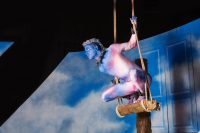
top-left (0, 92), bottom-right (128, 133)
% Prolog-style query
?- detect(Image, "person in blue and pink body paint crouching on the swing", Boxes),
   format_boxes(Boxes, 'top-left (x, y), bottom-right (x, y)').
top-left (82, 18), bottom-right (151, 103)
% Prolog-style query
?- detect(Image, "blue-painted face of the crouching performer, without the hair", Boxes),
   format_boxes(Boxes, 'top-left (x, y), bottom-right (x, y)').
top-left (84, 44), bottom-right (97, 59)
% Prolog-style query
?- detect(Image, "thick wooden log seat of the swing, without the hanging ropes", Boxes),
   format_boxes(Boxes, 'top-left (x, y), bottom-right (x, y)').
top-left (116, 100), bottom-right (160, 117)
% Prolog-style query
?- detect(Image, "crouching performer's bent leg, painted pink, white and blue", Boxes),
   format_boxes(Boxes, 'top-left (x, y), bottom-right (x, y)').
top-left (102, 82), bottom-right (138, 102)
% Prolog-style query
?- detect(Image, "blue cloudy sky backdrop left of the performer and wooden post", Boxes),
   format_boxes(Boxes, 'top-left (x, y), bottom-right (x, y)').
top-left (0, 52), bottom-right (137, 133)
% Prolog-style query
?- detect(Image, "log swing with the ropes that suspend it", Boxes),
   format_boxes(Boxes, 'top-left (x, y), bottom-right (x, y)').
top-left (114, 0), bottom-right (160, 117)
